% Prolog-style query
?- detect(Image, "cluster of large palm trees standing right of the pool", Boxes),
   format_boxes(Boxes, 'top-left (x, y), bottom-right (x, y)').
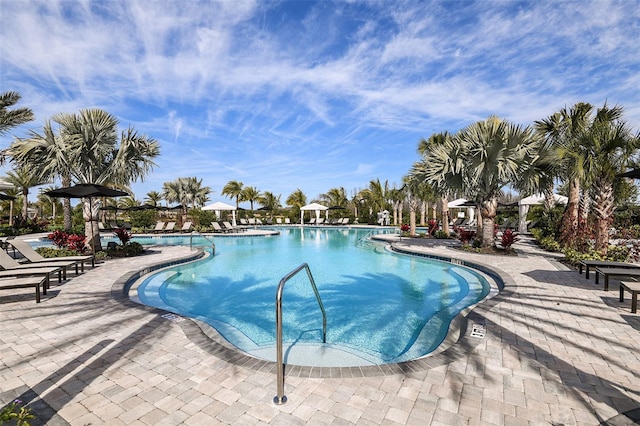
top-left (407, 103), bottom-right (640, 253)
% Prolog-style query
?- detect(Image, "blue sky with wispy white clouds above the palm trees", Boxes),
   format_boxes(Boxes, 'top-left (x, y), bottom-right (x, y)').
top-left (0, 0), bottom-right (640, 204)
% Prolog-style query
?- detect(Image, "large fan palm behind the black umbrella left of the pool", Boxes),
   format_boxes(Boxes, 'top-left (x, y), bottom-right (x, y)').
top-left (10, 109), bottom-right (160, 250)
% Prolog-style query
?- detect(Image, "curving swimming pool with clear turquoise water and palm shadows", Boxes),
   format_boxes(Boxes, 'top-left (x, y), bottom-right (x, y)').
top-left (136, 227), bottom-right (490, 366)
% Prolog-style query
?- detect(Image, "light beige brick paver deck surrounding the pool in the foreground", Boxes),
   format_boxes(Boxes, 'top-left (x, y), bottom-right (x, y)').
top-left (0, 235), bottom-right (640, 425)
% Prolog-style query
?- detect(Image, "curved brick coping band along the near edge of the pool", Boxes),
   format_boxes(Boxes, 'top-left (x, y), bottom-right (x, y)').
top-left (111, 243), bottom-right (517, 378)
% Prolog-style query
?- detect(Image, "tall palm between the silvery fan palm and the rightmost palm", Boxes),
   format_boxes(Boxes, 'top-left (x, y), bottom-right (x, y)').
top-left (535, 102), bottom-right (593, 244)
